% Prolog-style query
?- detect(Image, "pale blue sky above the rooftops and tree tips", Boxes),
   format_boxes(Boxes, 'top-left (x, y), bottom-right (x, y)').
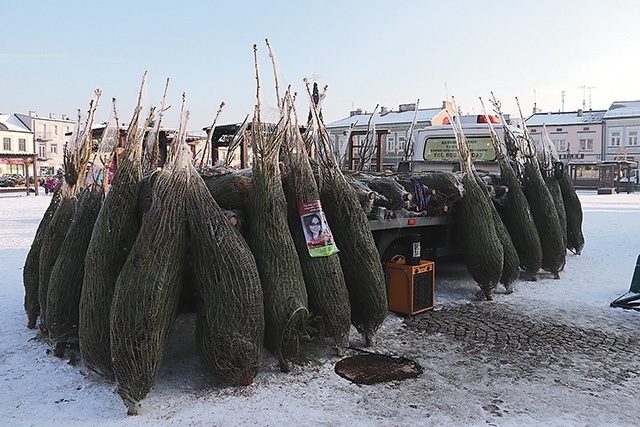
top-left (0, 0), bottom-right (640, 130)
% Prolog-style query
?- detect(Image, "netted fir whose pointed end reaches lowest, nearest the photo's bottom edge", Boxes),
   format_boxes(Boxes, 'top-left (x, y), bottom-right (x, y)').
top-left (110, 170), bottom-right (187, 414)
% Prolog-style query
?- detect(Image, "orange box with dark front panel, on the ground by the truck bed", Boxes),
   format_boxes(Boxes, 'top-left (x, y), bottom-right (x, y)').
top-left (385, 260), bottom-right (435, 315)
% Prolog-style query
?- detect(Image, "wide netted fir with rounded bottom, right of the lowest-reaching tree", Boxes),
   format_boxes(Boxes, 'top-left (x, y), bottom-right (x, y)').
top-left (187, 170), bottom-right (264, 385)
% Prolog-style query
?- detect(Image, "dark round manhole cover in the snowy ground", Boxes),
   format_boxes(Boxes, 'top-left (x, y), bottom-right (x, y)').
top-left (335, 354), bottom-right (422, 384)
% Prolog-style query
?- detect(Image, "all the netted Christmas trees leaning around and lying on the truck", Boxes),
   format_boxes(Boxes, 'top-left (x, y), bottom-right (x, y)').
top-left (24, 47), bottom-right (584, 414)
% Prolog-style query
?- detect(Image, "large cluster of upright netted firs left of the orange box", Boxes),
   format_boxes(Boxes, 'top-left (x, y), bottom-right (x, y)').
top-left (24, 59), bottom-right (386, 414)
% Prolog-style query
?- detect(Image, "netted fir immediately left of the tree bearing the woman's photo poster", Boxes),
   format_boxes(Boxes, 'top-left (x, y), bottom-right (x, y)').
top-left (248, 84), bottom-right (308, 372)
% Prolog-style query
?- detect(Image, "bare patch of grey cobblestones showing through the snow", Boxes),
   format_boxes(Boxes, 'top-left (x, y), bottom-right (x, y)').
top-left (405, 302), bottom-right (640, 383)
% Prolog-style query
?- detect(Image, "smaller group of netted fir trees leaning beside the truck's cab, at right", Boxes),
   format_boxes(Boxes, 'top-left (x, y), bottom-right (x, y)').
top-left (450, 94), bottom-right (584, 299)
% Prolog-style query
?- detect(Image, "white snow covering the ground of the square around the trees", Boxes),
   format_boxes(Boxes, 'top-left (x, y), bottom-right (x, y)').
top-left (0, 191), bottom-right (640, 427)
